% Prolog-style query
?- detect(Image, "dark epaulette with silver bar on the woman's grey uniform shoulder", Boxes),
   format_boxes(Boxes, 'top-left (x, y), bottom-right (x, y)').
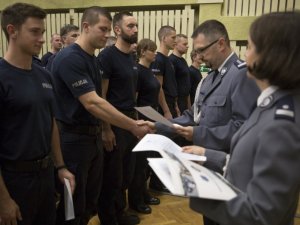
top-left (274, 95), bottom-right (295, 122)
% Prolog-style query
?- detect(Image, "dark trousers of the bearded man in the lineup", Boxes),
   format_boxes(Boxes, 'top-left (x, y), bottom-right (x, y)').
top-left (98, 111), bottom-right (138, 225)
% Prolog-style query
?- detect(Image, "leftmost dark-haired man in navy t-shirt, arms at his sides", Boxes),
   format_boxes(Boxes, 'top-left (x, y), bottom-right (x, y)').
top-left (0, 3), bottom-right (75, 225)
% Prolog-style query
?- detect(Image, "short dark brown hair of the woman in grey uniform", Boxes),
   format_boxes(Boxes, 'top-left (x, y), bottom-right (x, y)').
top-left (248, 11), bottom-right (300, 89)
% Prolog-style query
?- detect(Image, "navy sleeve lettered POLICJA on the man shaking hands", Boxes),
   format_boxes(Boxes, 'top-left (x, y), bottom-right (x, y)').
top-left (54, 54), bottom-right (95, 98)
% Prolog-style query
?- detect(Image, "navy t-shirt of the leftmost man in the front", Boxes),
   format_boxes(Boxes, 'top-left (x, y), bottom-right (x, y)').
top-left (0, 59), bottom-right (54, 161)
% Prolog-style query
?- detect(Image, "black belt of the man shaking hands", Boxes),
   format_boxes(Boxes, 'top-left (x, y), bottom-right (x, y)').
top-left (56, 121), bottom-right (101, 135)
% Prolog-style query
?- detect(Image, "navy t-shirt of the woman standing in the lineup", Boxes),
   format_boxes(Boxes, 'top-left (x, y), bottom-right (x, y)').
top-left (137, 64), bottom-right (160, 108)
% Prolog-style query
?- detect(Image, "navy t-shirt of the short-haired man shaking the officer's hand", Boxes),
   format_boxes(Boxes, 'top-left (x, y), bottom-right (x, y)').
top-left (51, 43), bottom-right (101, 125)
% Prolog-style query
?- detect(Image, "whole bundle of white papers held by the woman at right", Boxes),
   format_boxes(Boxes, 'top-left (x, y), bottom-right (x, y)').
top-left (133, 134), bottom-right (240, 200)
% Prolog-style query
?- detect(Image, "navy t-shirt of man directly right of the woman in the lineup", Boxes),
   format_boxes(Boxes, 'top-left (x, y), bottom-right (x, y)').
top-left (151, 52), bottom-right (178, 98)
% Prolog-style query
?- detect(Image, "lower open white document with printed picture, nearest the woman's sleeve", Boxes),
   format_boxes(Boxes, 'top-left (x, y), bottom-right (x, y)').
top-left (148, 153), bottom-right (237, 201)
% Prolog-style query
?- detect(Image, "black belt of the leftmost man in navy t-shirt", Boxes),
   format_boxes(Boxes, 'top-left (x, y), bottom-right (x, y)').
top-left (1, 156), bottom-right (53, 173)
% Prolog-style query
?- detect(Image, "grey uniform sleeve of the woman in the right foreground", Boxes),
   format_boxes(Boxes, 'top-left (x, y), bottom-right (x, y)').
top-left (190, 120), bottom-right (300, 225)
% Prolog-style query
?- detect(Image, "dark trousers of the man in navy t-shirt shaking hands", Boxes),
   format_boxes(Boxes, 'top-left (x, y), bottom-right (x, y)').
top-left (56, 129), bottom-right (103, 225)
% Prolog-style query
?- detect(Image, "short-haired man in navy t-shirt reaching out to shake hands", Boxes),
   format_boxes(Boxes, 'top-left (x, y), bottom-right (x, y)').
top-left (52, 6), bottom-right (147, 224)
